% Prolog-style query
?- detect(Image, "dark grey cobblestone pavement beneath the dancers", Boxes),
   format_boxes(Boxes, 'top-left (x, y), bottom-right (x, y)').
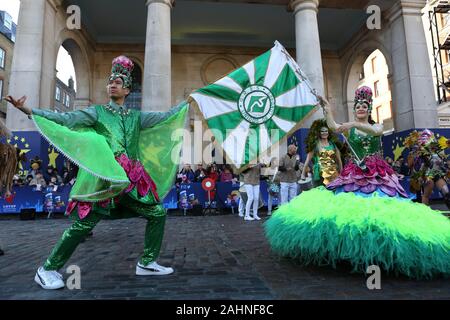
top-left (0, 205), bottom-right (450, 300)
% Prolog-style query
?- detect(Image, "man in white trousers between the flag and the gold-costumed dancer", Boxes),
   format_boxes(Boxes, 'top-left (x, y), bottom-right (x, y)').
top-left (278, 144), bottom-right (300, 205)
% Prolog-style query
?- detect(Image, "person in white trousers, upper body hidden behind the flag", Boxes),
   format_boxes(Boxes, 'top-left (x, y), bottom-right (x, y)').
top-left (243, 164), bottom-right (263, 221)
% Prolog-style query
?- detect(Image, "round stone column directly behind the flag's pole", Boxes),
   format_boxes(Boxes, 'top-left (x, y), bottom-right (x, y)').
top-left (290, 0), bottom-right (324, 128)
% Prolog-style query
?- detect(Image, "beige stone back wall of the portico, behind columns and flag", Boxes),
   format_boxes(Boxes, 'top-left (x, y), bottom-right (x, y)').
top-left (89, 44), bottom-right (332, 111)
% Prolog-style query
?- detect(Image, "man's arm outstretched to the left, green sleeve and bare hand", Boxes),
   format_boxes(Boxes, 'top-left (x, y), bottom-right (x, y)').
top-left (5, 96), bottom-right (97, 128)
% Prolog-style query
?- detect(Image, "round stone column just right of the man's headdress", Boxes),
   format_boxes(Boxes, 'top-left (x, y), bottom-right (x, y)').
top-left (142, 0), bottom-right (173, 111)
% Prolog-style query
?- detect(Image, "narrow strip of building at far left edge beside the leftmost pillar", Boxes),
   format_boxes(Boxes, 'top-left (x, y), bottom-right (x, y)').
top-left (0, 11), bottom-right (17, 118)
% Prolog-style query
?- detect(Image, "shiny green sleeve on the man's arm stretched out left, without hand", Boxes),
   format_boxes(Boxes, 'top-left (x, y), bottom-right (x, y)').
top-left (32, 106), bottom-right (97, 129)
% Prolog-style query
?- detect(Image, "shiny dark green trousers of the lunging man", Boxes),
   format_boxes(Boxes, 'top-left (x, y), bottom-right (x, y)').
top-left (44, 196), bottom-right (166, 270)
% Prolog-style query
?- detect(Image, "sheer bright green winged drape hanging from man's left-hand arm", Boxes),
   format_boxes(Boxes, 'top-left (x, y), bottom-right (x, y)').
top-left (33, 110), bottom-right (130, 202)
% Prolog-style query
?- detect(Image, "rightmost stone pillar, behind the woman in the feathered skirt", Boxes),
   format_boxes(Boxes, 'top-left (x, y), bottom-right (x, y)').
top-left (387, 0), bottom-right (438, 131)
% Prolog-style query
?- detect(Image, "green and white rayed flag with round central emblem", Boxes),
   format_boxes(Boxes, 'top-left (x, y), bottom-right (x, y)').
top-left (191, 41), bottom-right (318, 169)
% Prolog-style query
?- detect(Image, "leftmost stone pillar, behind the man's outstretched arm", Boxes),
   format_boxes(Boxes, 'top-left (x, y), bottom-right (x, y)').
top-left (6, 0), bottom-right (46, 130)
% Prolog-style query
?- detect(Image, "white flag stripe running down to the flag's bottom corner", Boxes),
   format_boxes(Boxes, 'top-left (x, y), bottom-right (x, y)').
top-left (222, 120), bottom-right (250, 168)
